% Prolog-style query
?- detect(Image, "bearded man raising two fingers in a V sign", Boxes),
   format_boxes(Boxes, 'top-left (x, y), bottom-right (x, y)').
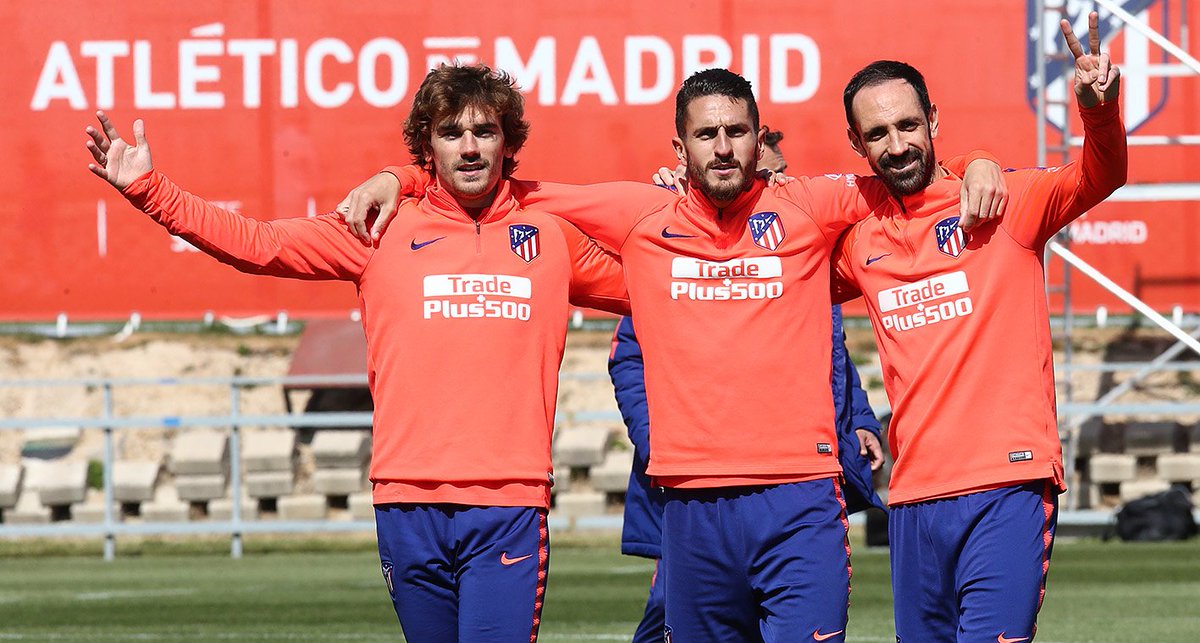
top-left (834, 13), bottom-right (1128, 643)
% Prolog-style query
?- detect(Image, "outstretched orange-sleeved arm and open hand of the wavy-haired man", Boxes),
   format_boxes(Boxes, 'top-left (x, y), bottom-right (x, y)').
top-left (86, 113), bottom-right (371, 281)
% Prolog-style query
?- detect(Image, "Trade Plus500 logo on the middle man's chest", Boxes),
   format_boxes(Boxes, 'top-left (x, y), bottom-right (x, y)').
top-left (671, 257), bottom-right (784, 301)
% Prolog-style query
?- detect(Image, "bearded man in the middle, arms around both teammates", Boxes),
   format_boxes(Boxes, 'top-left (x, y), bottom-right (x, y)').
top-left (343, 70), bottom-right (994, 641)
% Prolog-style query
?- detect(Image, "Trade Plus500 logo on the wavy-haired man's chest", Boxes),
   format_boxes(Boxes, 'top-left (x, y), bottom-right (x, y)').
top-left (424, 275), bottom-right (533, 322)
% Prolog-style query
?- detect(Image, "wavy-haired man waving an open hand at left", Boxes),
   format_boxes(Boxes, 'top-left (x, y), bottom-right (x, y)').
top-left (88, 66), bottom-right (629, 643)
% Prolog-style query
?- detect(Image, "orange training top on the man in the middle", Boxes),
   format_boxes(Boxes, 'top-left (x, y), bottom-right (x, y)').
top-left (388, 152), bottom-right (988, 487)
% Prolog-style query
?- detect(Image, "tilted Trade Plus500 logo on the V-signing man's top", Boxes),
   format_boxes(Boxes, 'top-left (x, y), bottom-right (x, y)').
top-left (876, 270), bottom-right (974, 331)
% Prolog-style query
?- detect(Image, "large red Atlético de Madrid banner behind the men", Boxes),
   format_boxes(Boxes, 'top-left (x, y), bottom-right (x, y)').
top-left (0, 0), bottom-right (1200, 319)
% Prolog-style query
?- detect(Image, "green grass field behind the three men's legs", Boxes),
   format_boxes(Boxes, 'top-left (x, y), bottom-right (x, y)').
top-left (0, 539), bottom-right (1200, 643)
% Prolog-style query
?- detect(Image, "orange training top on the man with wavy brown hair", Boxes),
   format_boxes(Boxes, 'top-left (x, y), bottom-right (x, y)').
top-left (125, 170), bottom-right (629, 507)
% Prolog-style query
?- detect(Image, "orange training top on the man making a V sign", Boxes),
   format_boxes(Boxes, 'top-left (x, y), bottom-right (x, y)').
top-left (834, 102), bottom-right (1127, 505)
